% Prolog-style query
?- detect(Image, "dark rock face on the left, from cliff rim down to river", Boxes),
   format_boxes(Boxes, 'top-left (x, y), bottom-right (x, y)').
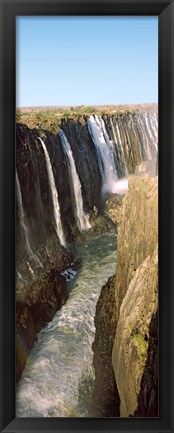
top-left (16, 120), bottom-right (104, 380)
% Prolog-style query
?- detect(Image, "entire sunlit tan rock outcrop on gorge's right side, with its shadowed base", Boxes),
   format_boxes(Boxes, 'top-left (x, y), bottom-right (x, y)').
top-left (93, 177), bottom-right (158, 417)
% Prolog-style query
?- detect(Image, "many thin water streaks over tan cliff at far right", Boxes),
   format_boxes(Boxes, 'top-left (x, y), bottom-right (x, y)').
top-left (101, 113), bottom-right (158, 172)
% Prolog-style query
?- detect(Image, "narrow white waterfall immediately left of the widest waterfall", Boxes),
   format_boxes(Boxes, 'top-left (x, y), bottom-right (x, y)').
top-left (59, 129), bottom-right (91, 231)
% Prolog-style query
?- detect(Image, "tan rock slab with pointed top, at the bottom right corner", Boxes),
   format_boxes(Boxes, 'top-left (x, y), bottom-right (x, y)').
top-left (112, 246), bottom-right (158, 417)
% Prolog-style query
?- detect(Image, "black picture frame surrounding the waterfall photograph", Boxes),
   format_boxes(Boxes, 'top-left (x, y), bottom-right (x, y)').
top-left (0, 0), bottom-right (174, 433)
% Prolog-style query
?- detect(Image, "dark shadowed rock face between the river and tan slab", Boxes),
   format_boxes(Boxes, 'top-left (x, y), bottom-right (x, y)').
top-left (92, 275), bottom-right (120, 417)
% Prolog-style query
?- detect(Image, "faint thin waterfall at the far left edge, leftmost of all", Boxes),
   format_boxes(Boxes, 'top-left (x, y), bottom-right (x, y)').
top-left (16, 171), bottom-right (42, 268)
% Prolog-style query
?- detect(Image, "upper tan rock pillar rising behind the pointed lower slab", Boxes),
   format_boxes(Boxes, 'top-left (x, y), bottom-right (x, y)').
top-left (112, 177), bottom-right (158, 322)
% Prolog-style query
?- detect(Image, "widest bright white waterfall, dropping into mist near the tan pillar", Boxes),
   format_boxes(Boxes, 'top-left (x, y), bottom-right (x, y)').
top-left (87, 115), bottom-right (118, 192)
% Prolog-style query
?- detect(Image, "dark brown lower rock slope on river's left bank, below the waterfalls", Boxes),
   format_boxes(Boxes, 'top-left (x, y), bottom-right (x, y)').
top-left (16, 250), bottom-right (76, 381)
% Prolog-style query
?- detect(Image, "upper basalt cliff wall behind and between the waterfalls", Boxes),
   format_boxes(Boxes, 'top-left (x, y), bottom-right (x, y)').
top-left (16, 112), bottom-right (157, 276)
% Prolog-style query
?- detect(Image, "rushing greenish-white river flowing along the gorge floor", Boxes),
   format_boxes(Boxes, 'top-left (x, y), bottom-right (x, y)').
top-left (16, 230), bottom-right (116, 417)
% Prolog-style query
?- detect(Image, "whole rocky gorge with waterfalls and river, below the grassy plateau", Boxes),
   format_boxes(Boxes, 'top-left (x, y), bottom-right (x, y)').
top-left (16, 106), bottom-right (158, 417)
